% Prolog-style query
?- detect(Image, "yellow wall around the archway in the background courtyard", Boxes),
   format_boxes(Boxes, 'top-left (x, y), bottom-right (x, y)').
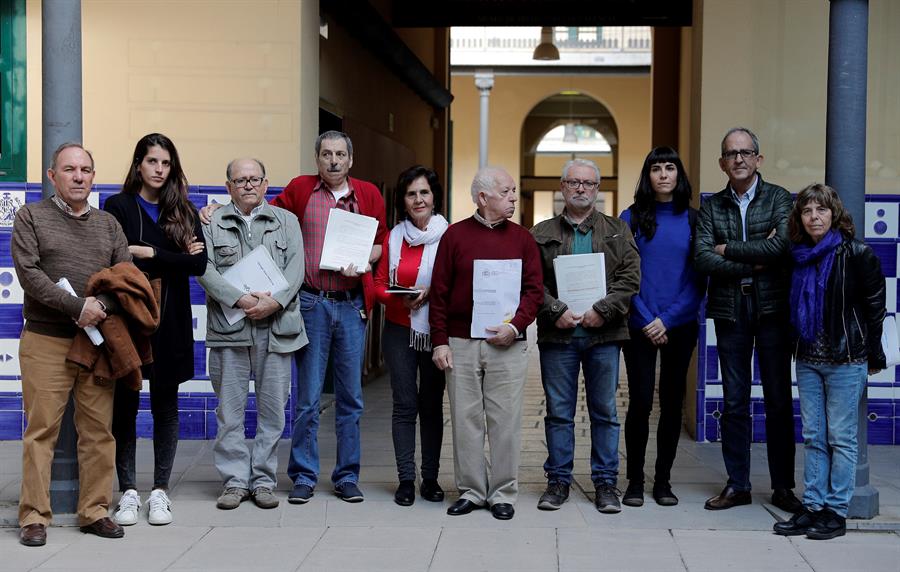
top-left (450, 74), bottom-right (650, 222)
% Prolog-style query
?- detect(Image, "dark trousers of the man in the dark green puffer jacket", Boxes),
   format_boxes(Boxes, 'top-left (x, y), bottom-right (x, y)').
top-left (716, 295), bottom-right (795, 491)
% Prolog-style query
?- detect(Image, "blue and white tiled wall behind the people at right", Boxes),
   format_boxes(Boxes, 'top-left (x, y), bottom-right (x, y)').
top-left (696, 195), bottom-right (900, 445)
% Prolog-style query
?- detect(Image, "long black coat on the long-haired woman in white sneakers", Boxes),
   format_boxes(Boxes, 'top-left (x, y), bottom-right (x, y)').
top-left (103, 193), bottom-right (207, 384)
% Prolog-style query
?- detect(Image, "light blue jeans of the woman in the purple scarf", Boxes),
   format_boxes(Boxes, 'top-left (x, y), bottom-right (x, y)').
top-left (797, 361), bottom-right (868, 518)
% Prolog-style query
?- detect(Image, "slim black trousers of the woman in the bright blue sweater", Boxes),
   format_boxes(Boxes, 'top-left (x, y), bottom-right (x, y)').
top-left (622, 322), bottom-right (699, 483)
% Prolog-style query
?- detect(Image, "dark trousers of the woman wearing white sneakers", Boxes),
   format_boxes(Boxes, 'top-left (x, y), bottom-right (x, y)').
top-left (112, 378), bottom-right (178, 492)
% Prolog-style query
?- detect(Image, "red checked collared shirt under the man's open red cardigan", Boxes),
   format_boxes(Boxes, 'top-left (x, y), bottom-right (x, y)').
top-left (300, 178), bottom-right (365, 291)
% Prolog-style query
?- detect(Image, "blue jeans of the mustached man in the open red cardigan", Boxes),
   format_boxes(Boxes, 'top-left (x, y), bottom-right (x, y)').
top-left (288, 290), bottom-right (366, 487)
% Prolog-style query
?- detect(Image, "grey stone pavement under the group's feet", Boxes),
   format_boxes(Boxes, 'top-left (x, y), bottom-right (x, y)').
top-left (0, 338), bottom-right (900, 572)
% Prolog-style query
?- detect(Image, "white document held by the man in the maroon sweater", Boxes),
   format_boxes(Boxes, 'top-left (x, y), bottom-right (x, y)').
top-left (469, 258), bottom-right (522, 338)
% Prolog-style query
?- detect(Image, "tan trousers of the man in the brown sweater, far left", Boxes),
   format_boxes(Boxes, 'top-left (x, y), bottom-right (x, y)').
top-left (19, 331), bottom-right (116, 526)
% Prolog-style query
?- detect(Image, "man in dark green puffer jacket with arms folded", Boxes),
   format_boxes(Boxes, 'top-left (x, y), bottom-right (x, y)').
top-left (694, 127), bottom-right (802, 512)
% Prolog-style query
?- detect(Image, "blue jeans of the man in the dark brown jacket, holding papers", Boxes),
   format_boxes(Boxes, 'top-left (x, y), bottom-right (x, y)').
top-left (538, 338), bottom-right (619, 485)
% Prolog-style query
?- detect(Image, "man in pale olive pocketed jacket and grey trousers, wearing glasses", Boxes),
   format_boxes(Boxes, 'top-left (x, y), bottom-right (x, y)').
top-left (198, 159), bottom-right (308, 510)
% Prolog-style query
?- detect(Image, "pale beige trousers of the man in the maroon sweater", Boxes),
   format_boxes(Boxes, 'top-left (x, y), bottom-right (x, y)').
top-left (447, 338), bottom-right (528, 505)
